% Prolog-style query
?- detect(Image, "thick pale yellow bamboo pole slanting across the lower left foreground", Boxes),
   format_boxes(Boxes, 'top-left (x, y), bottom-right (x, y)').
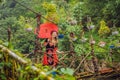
top-left (0, 45), bottom-right (54, 80)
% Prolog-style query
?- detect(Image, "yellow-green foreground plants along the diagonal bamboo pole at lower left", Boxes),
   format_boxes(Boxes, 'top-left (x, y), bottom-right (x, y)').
top-left (0, 44), bottom-right (75, 80)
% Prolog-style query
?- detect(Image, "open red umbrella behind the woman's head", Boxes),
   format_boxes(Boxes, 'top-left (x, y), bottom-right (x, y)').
top-left (38, 23), bottom-right (58, 38)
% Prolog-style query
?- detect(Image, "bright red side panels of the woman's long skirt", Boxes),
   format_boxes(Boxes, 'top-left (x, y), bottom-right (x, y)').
top-left (43, 48), bottom-right (58, 66)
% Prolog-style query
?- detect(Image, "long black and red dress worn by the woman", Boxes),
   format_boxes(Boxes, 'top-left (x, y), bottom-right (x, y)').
top-left (43, 39), bottom-right (58, 66)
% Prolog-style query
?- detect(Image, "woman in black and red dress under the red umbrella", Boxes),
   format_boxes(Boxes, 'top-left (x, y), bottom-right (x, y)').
top-left (43, 31), bottom-right (58, 66)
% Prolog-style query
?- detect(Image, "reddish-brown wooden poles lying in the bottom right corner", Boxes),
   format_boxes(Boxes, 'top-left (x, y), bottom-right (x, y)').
top-left (76, 68), bottom-right (120, 80)
